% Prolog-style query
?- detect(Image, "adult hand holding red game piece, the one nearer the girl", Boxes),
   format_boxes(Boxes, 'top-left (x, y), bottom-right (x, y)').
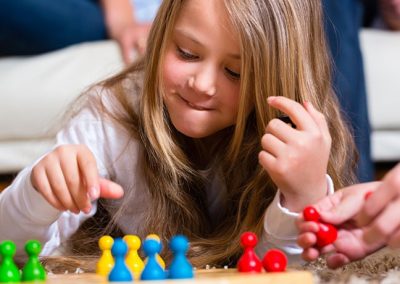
top-left (297, 182), bottom-right (385, 268)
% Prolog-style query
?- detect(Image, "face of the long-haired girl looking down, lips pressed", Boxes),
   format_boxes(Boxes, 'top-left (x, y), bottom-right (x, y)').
top-left (162, 0), bottom-right (241, 138)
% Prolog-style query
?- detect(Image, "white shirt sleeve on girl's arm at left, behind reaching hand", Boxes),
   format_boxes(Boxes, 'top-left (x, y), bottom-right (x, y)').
top-left (0, 102), bottom-right (114, 260)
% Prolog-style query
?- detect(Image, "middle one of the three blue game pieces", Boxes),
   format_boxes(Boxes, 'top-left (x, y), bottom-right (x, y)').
top-left (140, 239), bottom-right (166, 280)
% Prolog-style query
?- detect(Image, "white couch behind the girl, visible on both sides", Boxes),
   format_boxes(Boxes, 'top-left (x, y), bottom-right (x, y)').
top-left (0, 30), bottom-right (400, 174)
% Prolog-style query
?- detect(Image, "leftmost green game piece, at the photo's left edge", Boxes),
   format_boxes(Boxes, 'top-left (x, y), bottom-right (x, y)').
top-left (0, 240), bottom-right (21, 283)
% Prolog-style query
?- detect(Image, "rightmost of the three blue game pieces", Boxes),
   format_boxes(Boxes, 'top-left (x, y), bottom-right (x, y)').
top-left (169, 235), bottom-right (193, 279)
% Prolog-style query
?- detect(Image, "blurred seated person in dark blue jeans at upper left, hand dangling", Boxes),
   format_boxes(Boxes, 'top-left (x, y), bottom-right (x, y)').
top-left (0, 0), bottom-right (161, 63)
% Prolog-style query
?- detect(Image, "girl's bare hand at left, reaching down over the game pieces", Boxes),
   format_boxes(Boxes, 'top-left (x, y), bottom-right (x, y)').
top-left (31, 145), bottom-right (124, 214)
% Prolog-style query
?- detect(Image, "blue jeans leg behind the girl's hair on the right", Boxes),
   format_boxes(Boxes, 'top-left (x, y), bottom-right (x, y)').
top-left (323, 0), bottom-right (374, 182)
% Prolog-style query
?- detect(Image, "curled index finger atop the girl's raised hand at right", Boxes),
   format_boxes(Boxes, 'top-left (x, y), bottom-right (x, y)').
top-left (267, 96), bottom-right (316, 130)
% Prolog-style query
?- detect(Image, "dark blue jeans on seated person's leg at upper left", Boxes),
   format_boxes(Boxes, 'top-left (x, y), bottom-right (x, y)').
top-left (0, 0), bottom-right (106, 56)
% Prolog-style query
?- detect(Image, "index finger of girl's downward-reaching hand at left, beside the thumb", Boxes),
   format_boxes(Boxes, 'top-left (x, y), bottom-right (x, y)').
top-left (77, 148), bottom-right (100, 200)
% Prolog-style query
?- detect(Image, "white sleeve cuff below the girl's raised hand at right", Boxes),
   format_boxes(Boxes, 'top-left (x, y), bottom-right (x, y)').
top-left (256, 175), bottom-right (334, 263)
